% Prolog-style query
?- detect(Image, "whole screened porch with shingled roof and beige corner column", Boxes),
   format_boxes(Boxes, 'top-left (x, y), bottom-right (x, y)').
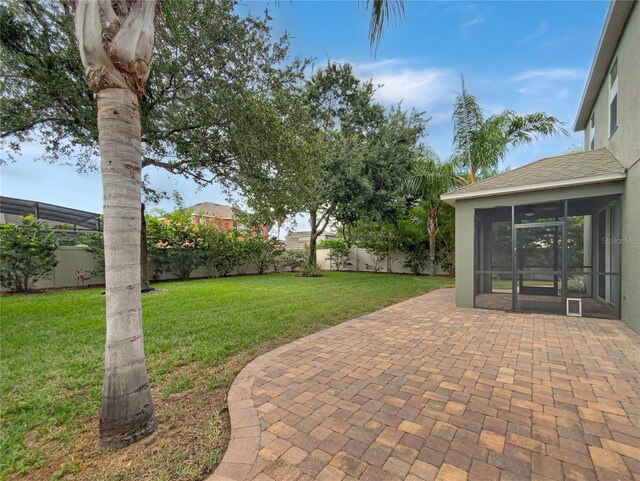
top-left (442, 149), bottom-right (626, 319)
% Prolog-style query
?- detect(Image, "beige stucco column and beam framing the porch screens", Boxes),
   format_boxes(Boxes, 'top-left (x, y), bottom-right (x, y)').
top-left (456, 182), bottom-right (631, 308)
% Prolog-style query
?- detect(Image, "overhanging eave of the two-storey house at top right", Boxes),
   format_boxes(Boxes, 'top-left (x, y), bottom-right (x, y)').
top-left (573, 0), bottom-right (638, 132)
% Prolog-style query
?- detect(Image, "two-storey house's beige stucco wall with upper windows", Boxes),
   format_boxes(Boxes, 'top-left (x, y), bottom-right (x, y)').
top-left (581, 5), bottom-right (640, 333)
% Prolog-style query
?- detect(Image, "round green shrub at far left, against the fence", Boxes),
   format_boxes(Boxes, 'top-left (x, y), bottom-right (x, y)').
top-left (0, 216), bottom-right (58, 292)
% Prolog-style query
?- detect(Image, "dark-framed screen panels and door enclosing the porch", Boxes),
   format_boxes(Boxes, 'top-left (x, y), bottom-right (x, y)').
top-left (474, 195), bottom-right (621, 318)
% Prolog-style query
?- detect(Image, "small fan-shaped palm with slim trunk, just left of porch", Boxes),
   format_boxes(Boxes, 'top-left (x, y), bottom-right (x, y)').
top-left (403, 148), bottom-right (463, 276)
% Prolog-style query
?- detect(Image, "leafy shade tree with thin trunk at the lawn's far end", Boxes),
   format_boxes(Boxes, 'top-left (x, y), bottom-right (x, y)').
top-left (298, 63), bottom-right (424, 265)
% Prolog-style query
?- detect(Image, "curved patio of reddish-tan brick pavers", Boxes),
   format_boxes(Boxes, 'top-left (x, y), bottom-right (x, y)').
top-left (209, 289), bottom-right (640, 481)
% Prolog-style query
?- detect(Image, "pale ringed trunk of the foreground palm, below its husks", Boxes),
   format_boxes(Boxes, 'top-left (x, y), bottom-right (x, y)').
top-left (98, 88), bottom-right (156, 448)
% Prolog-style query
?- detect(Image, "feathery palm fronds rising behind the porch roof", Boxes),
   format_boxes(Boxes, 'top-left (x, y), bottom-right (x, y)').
top-left (453, 83), bottom-right (568, 184)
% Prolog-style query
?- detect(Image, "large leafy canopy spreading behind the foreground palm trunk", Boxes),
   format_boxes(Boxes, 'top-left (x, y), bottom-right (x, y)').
top-left (0, 0), bottom-right (307, 204)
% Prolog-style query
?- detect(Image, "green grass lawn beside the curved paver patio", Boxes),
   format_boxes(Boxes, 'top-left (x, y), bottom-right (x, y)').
top-left (0, 272), bottom-right (453, 479)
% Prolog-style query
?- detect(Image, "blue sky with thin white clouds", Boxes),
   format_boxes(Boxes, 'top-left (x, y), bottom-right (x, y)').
top-left (0, 0), bottom-right (609, 223)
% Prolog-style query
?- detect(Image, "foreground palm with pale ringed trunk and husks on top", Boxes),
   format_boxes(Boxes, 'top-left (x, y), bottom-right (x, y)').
top-left (75, 0), bottom-right (156, 448)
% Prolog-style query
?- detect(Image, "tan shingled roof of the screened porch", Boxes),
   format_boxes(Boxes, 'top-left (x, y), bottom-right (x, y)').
top-left (441, 148), bottom-right (626, 204)
